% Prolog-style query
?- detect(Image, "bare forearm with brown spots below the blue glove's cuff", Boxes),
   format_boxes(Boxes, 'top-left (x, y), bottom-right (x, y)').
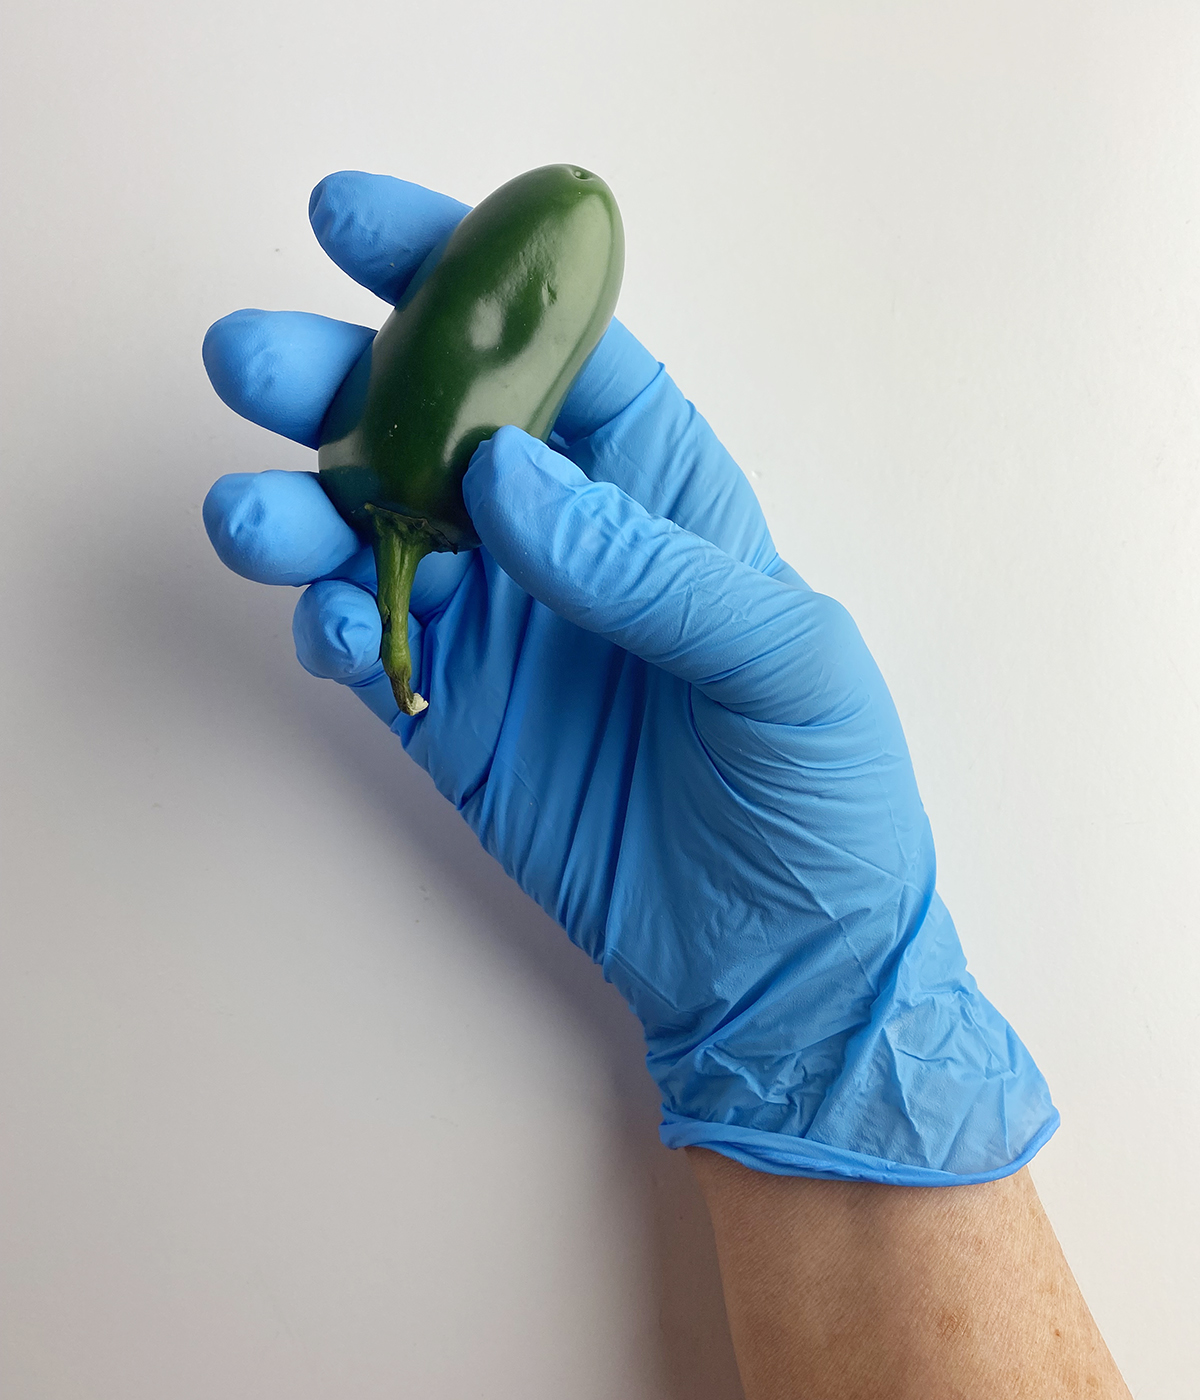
top-left (689, 1148), bottom-right (1129, 1400)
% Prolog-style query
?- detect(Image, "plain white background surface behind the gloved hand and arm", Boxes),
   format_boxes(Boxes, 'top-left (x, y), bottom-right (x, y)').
top-left (0, 0), bottom-right (1200, 1400)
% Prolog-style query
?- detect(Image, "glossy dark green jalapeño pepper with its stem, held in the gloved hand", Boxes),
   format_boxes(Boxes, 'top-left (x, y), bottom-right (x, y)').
top-left (318, 165), bottom-right (625, 714)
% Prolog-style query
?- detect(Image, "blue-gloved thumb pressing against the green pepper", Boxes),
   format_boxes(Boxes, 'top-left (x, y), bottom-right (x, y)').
top-left (462, 427), bottom-right (874, 724)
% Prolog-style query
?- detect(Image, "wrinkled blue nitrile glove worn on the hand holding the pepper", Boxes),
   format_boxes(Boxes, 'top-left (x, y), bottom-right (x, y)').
top-left (204, 174), bottom-right (1057, 1184)
